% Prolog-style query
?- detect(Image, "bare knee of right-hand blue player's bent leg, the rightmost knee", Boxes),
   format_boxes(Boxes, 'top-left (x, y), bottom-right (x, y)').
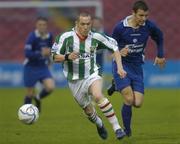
top-left (134, 91), bottom-right (144, 107)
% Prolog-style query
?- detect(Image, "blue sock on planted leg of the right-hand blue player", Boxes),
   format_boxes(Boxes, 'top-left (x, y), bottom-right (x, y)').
top-left (121, 104), bottom-right (132, 132)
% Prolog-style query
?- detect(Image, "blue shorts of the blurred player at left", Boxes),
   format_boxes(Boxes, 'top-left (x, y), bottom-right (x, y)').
top-left (24, 66), bottom-right (52, 87)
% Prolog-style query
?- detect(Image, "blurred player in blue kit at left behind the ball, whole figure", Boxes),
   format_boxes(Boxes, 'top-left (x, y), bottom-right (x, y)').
top-left (24, 17), bottom-right (54, 111)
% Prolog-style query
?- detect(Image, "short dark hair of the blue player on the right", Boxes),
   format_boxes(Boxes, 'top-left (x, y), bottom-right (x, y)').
top-left (132, 0), bottom-right (149, 12)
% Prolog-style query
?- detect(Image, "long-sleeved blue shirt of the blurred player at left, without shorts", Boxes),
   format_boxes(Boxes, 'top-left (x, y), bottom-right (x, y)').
top-left (25, 30), bottom-right (53, 67)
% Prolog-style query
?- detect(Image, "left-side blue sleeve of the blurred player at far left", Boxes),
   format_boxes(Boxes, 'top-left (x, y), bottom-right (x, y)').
top-left (24, 33), bottom-right (41, 59)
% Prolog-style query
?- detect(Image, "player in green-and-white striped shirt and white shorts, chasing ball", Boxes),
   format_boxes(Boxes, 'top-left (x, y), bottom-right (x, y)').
top-left (51, 13), bottom-right (126, 139)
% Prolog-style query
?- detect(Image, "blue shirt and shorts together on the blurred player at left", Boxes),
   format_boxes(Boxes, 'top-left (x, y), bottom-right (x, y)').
top-left (24, 30), bottom-right (53, 87)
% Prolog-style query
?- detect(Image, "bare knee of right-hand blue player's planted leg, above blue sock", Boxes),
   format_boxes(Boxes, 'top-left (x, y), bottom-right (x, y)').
top-left (121, 86), bottom-right (134, 105)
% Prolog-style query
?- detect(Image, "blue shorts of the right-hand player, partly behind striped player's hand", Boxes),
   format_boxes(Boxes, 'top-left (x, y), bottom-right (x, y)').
top-left (113, 62), bottom-right (144, 94)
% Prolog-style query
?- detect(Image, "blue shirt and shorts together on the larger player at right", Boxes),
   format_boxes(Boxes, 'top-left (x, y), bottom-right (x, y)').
top-left (112, 16), bottom-right (164, 94)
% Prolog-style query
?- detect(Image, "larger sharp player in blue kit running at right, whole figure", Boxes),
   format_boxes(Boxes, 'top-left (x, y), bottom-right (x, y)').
top-left (108, 1), bottom-right (165, 136)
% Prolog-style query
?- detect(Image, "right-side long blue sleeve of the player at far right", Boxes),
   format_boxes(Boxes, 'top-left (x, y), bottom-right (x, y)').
top-left (149, 22), bottom-right (164, 58)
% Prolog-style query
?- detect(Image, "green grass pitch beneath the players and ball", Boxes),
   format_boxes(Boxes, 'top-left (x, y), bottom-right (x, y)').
top-left (0, 88), bottom-right (180, 144)
